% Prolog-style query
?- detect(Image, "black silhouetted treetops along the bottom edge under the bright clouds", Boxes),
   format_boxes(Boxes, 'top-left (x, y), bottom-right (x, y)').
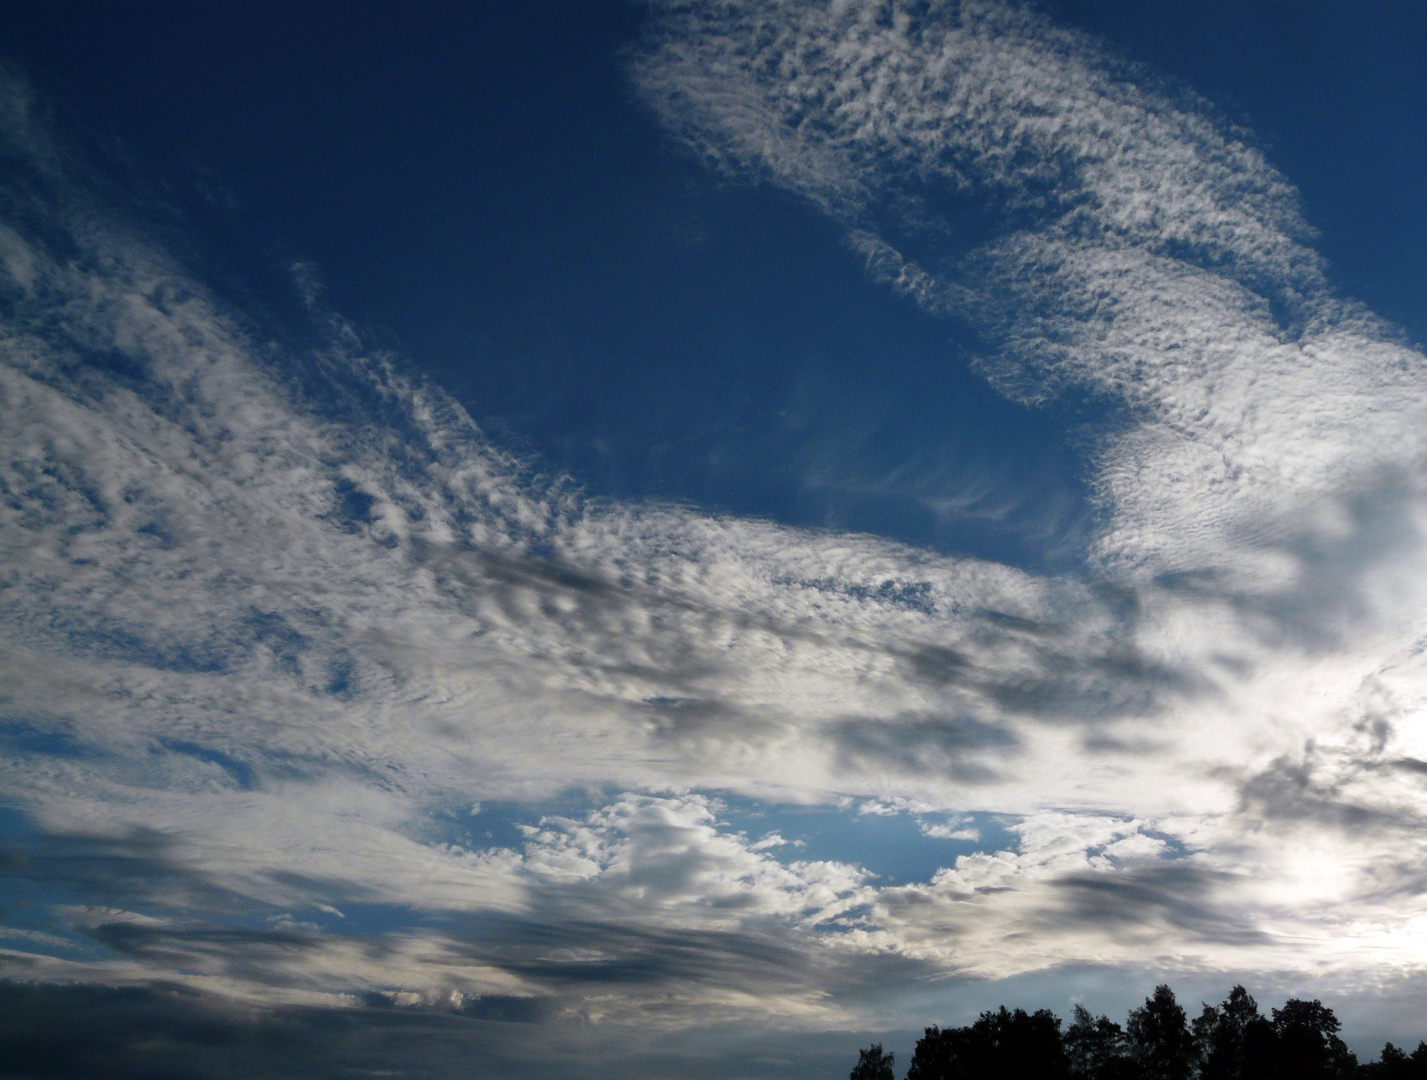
top-left (850, 986), bottom-right (1427, 1080)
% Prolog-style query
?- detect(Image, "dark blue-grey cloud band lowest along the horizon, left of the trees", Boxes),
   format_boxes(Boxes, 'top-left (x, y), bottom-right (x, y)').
top-left (0, 982), bottom-right (890, 1080)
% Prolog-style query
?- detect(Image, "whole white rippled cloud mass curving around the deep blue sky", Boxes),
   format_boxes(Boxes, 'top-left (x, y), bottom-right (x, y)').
top-left (0, 1), bottom-right (1427, 1055)
